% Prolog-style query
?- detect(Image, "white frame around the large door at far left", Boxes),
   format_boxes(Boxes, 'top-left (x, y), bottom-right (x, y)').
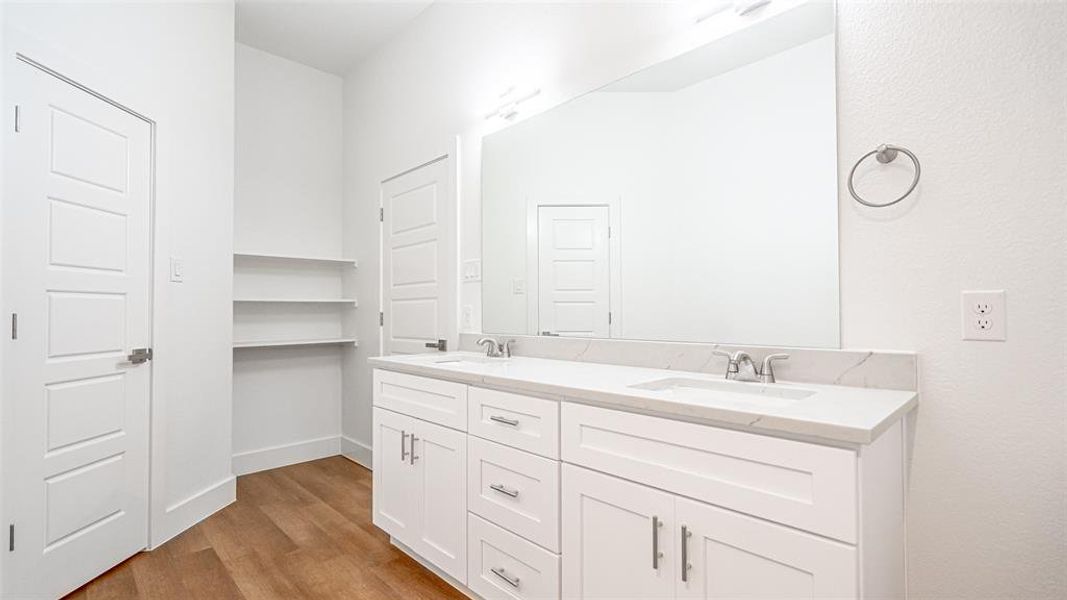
top-left (0, 32), bottom-right (162, 593)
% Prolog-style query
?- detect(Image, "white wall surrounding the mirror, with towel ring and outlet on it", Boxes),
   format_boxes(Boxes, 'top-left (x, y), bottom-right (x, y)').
top-left (345, 0), bottom-right (1067, 598)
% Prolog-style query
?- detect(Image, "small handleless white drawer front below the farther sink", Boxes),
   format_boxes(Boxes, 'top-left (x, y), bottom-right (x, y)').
top-left (373, 368), bottom-right (467, 431)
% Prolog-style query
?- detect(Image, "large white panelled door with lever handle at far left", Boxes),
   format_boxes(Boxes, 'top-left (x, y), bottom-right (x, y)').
top-left (3, 58), bottom-right (152, 598)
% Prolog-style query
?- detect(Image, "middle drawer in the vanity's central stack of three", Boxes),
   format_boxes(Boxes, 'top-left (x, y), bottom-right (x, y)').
top-left (467, 436), bottom-right (559, 552)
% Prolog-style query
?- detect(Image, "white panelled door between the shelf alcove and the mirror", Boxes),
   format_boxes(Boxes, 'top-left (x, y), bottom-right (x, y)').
top-left (381, 156), bottom-right (458, 356)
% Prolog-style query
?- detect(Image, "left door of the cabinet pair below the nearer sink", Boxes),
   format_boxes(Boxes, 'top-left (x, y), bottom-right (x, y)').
top-left (562, 464), bottom-right (678, 600)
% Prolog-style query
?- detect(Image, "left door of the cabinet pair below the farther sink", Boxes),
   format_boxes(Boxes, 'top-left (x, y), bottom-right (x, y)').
top-left (373, 408), bottom-right (419, 546)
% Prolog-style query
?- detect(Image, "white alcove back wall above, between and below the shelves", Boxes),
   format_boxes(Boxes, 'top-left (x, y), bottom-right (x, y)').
top-left (234, 44), bottom-right (345, 474)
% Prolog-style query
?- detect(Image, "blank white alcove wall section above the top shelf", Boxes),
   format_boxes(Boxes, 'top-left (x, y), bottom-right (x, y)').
top-left (234, 44), bottom-right (341, 256)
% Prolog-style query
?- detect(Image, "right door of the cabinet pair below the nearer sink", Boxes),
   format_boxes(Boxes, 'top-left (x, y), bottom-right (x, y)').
top-left (674, 498), bottom-right (857, 600)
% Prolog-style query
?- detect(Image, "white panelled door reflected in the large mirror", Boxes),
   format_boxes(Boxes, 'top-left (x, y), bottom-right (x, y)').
top-left (538, 206), bottom-right (611, 337)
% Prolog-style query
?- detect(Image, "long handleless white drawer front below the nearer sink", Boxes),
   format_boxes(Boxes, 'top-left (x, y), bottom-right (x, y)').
top-left (561, 402), bottom-right (857, 543)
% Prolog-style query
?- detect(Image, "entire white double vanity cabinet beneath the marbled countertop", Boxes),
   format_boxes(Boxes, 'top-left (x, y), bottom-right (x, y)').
top-left (373, 369), bottom-right (905, 600)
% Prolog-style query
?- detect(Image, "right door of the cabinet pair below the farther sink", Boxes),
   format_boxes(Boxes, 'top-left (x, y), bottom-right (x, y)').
top-left (412, 421), bottom-right (467, 584)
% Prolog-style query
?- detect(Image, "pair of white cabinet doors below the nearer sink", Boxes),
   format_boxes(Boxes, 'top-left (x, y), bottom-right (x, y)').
top-left (562, 464), bottom-right (857, 599)
